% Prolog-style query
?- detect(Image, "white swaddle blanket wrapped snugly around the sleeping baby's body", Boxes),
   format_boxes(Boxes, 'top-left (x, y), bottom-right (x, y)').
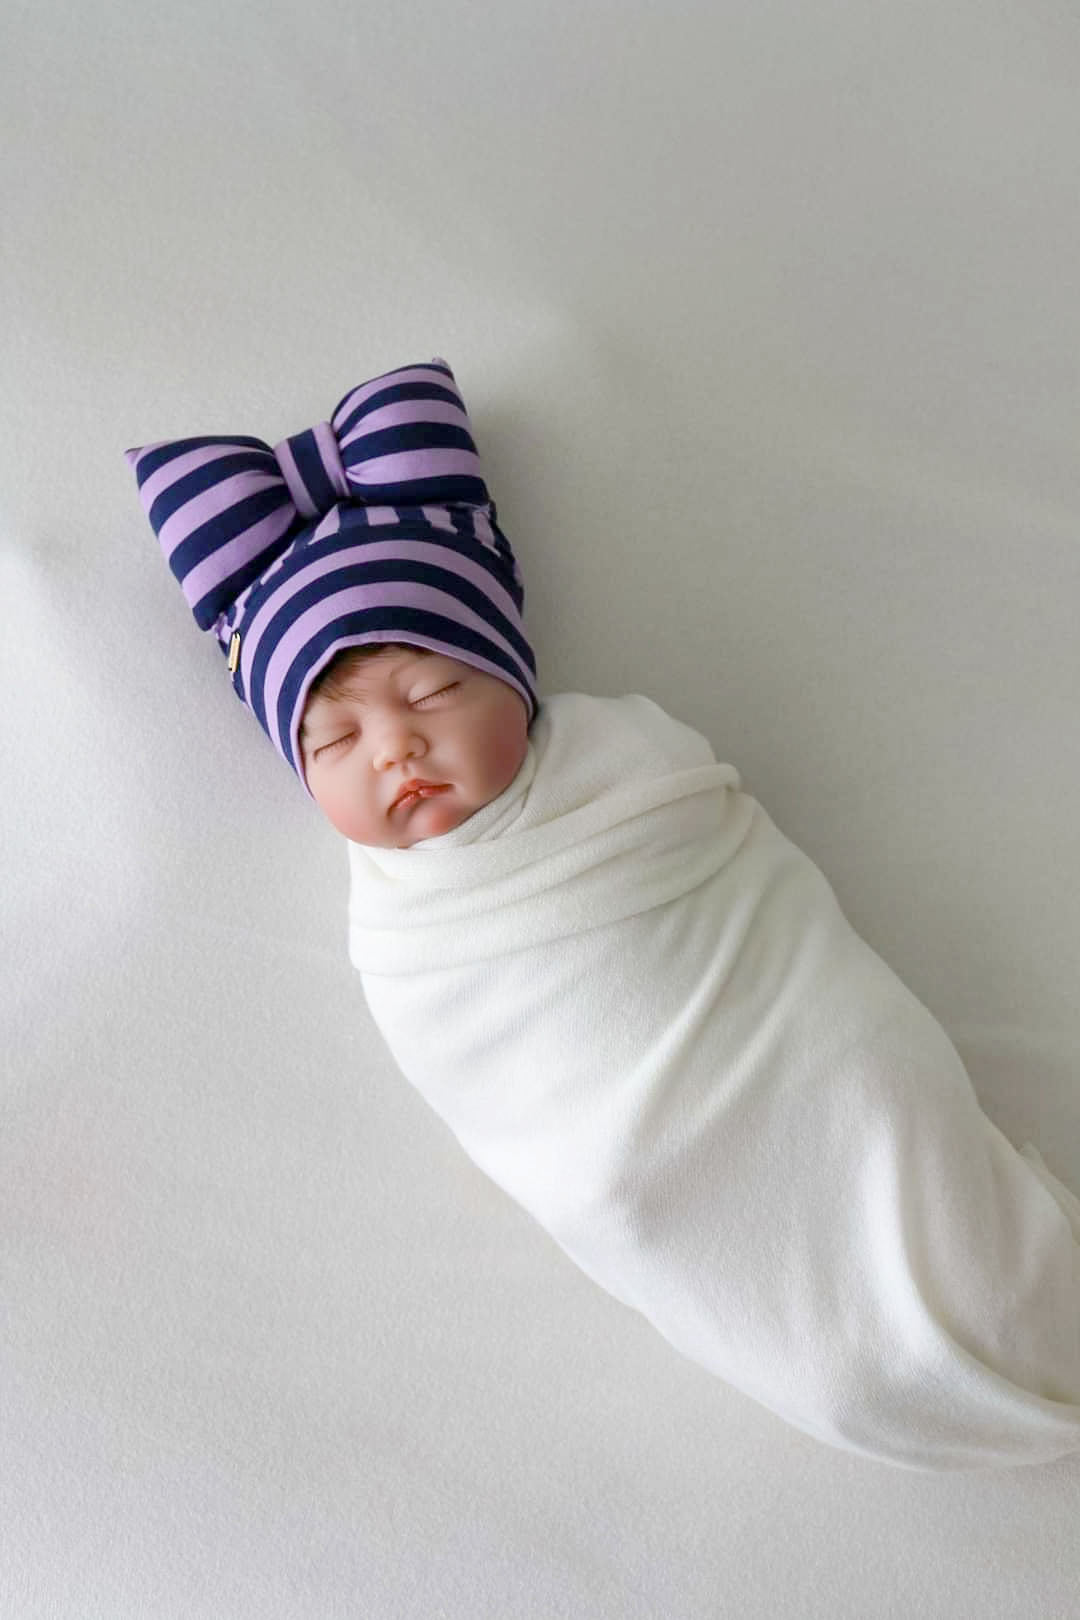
top-left (350, 693), bottom-right (1080, 1469)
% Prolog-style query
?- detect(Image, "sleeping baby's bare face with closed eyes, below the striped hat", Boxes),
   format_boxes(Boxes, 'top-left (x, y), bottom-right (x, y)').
top-left (300, 651), bottom-right (528, 849)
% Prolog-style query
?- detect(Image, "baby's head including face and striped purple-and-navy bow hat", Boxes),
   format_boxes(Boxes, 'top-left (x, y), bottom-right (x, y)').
top-left (126, 358), bottom-right (539, 822)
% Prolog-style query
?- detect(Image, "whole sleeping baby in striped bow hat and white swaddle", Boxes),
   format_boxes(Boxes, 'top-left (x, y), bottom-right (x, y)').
top-left (128, 360), bottom-right (1080, 1469)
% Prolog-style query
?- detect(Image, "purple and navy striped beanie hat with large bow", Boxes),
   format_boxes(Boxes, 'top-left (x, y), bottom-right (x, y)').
top-left (125, 358), bottom-right (538, 792)
